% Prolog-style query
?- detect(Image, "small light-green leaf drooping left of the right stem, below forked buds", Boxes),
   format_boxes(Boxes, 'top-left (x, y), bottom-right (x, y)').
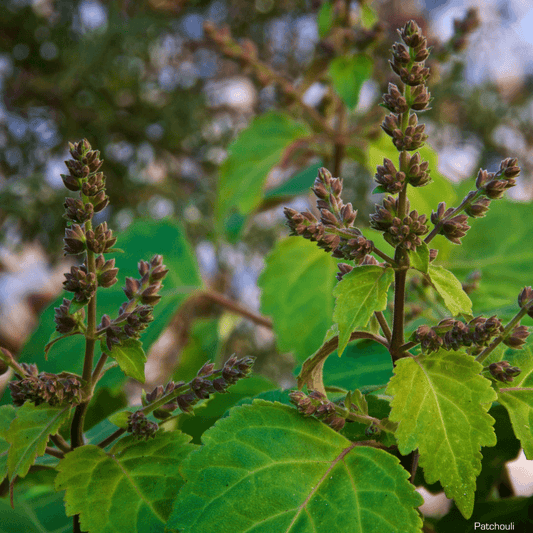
top-left (333, 265), bottom-right (394, 355)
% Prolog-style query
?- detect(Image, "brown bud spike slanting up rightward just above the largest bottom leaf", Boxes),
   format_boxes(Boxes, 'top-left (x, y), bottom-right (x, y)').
top-left (142, 355), bottom-right (254, 419)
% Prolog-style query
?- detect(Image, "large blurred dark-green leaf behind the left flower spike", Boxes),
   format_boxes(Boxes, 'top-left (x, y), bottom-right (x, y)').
top-left (2, 219), bottom-right (202, 403)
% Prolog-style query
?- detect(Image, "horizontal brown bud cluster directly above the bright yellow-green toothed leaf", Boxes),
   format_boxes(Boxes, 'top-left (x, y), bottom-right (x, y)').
top-left (411, 316), bottom-right (505, 354)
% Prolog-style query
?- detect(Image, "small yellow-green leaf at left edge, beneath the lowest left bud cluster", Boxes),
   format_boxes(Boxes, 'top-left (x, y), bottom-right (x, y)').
top-left (6, 402), bottom-right (70, 483)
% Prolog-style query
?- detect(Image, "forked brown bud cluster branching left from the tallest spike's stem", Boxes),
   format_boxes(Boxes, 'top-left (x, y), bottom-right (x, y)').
top-left (284, 168), bottom-right (374, 263)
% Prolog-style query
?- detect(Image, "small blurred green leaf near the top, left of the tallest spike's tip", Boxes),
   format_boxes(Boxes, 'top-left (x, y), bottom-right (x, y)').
top-left (328, 54), bottom-right (373, 109)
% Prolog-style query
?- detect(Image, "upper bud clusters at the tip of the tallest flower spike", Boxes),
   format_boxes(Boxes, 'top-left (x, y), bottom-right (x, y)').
top-left (381, 20), bottom-right (431, 151)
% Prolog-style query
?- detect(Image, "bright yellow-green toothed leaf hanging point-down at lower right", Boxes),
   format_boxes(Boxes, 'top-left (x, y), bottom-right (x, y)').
top-left (387, 350), bottom-right (496, 518)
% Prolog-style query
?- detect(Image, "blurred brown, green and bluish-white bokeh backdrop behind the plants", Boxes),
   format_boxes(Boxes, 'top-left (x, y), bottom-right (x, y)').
top-left (0, 0), bottom-right (533, 520)
